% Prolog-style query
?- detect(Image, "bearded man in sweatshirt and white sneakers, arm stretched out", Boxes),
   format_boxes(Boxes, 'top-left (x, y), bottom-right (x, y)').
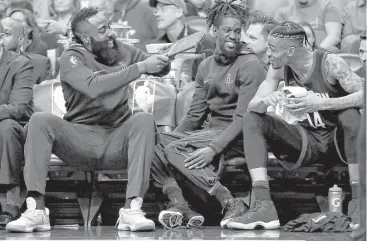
top-left (6, 8), bottom-right (170, 232)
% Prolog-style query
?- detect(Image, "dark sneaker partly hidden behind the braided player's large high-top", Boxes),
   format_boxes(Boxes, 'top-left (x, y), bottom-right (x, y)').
top-left (220, 198), bottom-right (248, 229)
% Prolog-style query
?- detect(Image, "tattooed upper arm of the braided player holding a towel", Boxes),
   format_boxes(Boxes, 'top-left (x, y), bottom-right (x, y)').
top-left (324, 54), bottom-right (364, 93)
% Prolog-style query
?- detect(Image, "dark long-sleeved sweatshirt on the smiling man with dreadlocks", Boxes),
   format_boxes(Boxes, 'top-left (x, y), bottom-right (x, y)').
top-left (175, 45), bottom-right (266, 153)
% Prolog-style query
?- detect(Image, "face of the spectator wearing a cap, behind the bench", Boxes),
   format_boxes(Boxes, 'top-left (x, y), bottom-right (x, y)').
top-left (154, 3), bottom-right (182, 30)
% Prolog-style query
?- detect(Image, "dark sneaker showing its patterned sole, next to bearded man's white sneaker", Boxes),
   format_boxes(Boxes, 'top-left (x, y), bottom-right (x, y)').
top-left (158, 202), bottom-right (204, 229)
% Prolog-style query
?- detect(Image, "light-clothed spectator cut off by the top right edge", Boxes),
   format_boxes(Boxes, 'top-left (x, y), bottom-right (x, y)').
top-left (341, 0), bottom-right (366, 54)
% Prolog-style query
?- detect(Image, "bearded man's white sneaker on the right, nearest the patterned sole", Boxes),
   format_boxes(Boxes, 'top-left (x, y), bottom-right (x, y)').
top-left (116, 197), bottom-right (155, 231)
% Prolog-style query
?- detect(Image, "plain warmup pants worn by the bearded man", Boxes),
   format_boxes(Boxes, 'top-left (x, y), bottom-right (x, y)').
top-left (24, 113), bottom-right (157, 198)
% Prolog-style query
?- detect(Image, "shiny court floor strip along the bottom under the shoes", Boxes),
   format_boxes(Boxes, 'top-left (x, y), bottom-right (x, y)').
top-left (0, 226), bottom-right (352, 241)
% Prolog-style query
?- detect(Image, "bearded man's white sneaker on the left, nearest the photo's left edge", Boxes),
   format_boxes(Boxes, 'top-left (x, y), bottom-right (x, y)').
top-left (5, 197), bottom-right (51, 233)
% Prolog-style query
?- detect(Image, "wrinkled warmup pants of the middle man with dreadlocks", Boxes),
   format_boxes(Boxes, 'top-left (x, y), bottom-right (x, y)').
top-left (152, 130), bottom-right (244, 193)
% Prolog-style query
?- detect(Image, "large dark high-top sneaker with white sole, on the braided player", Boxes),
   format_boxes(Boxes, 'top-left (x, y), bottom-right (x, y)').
top-left (227, 200), bottom-right (280, 230)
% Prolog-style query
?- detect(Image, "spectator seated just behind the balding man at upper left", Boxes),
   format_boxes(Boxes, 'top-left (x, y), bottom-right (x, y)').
top-left (9, 9), bottom-right (47, 57)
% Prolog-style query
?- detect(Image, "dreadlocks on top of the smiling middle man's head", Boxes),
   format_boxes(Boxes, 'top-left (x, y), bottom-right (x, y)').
top-left (206, 0), bottom-right (246, 28)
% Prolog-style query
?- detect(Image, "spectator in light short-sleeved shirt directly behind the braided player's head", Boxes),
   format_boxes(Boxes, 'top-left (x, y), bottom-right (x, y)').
top-left (274, 0), bottom-right (342, 52)
